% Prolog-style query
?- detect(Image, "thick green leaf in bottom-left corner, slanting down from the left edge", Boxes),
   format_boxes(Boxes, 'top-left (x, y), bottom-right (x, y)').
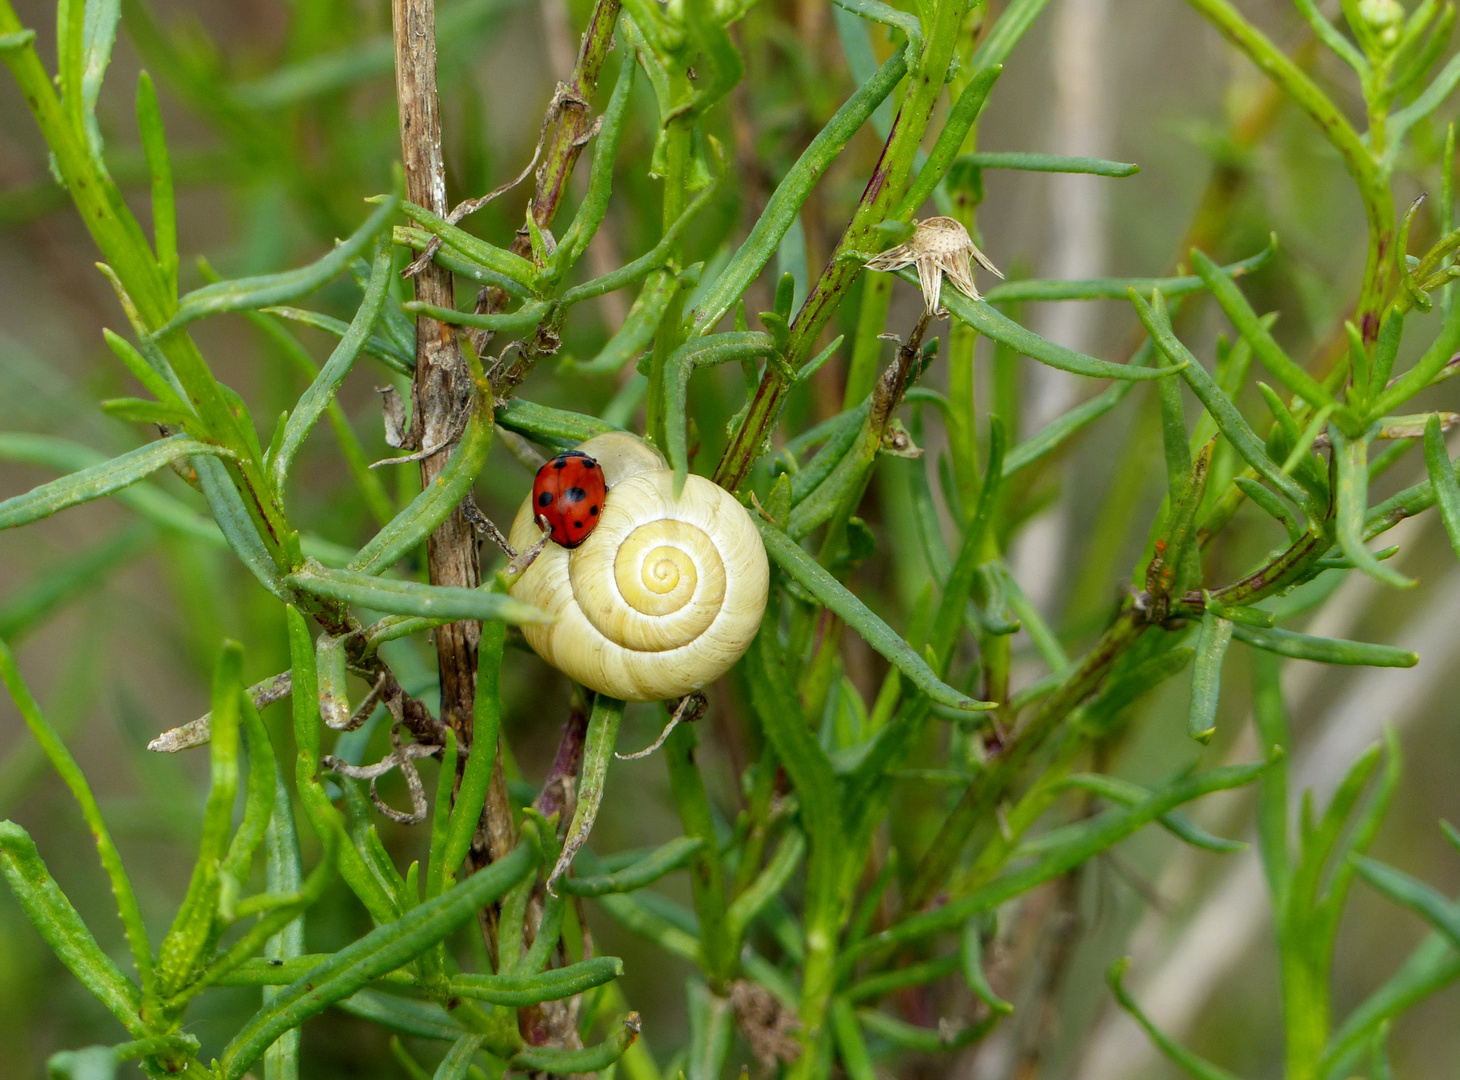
top-left (0, 822), bottom-right (149, 1038)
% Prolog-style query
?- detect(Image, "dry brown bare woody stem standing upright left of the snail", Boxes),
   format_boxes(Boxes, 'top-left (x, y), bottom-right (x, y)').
top-left (391, 0), bottom-right (514, 865)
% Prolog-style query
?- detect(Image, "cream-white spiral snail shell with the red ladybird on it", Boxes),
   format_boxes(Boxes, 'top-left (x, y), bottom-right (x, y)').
top-left (511, 432), bottom-right (769, 701)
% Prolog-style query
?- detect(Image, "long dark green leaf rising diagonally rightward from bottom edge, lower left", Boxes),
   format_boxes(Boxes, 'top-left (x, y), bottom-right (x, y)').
top-left (219, 844), bottom-right (537, 1080)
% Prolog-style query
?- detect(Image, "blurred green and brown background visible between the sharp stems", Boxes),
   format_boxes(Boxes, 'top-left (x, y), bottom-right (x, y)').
top-left (0, 0), bottom-right (1460, 1080)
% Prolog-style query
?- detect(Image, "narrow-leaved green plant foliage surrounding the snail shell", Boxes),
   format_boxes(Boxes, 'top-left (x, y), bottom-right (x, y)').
top-left (0, 0), bottom-right (1460, 1080)
